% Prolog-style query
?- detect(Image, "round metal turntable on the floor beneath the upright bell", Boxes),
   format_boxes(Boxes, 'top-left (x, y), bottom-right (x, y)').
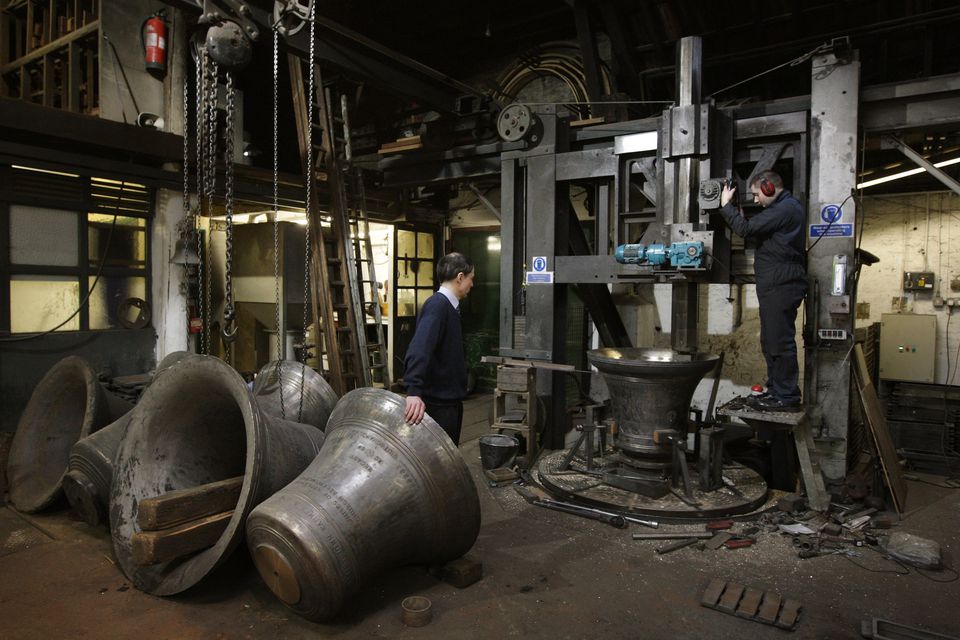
top-left (537, 451), bottom-right (767, 520)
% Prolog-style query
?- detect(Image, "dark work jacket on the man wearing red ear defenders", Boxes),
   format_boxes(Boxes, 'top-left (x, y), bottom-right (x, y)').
top-left (720, 190), bottom-right (807, 295)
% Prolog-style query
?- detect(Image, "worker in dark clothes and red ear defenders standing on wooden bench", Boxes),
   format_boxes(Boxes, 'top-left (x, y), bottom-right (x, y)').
top-left (720, 171), bottom-right (807, 411)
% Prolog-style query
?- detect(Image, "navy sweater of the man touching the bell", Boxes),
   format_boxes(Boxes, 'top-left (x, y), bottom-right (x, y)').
top-left (403, 292), bottom-right (467, 401)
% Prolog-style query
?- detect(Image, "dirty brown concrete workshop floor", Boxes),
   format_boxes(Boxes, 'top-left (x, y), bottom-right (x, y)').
top-left (0, 397), bottom-right (960, 640)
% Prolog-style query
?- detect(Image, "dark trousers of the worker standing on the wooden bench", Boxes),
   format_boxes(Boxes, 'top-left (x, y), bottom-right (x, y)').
top-left (757, 282), bottom-right (806, 403)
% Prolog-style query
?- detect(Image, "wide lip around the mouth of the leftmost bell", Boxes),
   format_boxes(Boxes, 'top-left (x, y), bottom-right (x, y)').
top-left (6, 355), bottom-right (102, 513)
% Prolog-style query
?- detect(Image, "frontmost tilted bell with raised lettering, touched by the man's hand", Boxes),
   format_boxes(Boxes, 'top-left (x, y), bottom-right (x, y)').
top-left (247, 388), bottom-right (480, 620)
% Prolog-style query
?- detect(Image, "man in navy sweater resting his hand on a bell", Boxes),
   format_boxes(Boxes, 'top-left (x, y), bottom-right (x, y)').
top-left (403, 253), bottom-right (473, 445)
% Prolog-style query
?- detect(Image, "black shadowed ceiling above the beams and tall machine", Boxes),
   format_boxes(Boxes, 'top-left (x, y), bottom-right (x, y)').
top-left (234, 0), bottom-right (960, 195)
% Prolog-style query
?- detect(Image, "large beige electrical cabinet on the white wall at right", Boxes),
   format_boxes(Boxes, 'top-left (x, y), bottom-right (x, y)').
top-left (880, 313), bottom-right (937, 382)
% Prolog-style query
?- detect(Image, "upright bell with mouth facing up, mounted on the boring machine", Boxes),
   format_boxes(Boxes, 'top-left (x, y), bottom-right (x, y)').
top-left (587, 348), bottom-right (719, 469)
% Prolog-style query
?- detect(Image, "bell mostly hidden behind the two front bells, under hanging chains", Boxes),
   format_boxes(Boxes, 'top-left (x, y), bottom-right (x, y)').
top-left (253, 360), bottom-right (338, 431)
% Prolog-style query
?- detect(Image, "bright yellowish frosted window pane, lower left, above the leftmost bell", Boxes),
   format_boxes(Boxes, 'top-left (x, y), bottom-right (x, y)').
top-left (10, 276), bottom-right (80, 333)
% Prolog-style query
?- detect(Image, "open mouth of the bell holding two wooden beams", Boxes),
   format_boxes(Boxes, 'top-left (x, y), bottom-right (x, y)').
top-left (110, 356), bottom-right (255, 595)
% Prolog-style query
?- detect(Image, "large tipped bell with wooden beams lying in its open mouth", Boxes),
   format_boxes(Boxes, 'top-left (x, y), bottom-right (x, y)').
top-left (110, 356), bottom-right (324, 596)
